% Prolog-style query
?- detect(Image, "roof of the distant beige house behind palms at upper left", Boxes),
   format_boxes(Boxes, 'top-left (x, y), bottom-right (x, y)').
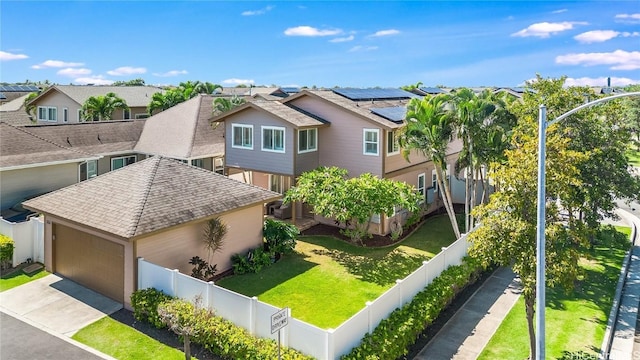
top-left (30, 85), bottom-right (164, 107)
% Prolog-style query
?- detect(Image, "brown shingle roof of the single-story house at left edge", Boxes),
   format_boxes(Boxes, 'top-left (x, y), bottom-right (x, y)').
top-left (0, 122), bottom-right (99, 170)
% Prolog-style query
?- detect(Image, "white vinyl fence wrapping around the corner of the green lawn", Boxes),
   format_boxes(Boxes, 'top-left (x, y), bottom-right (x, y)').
top-left (138, 234), bottom-right (469, 360)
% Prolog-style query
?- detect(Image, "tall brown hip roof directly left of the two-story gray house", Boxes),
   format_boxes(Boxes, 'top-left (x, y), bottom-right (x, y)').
top-left (134, 95), bottom-right (224, 160)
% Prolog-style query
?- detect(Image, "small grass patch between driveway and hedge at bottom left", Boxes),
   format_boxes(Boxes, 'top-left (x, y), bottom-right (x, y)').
top-left (72, 316), bottom-right (184, 360)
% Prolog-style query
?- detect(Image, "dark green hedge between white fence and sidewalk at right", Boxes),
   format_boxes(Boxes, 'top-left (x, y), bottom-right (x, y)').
top-left (341, 257), bottom-right (483, 360)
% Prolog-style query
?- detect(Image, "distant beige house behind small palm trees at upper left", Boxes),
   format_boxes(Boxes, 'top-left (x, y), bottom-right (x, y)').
top-left (29, 85), bottom-right (163, 125)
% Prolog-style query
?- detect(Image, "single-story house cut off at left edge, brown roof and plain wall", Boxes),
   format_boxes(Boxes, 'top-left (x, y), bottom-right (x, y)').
top-left (0, 122), bottom-right (100, 210)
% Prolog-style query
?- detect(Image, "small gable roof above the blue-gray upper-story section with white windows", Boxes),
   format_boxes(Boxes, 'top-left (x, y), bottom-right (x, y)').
top-left (212, 99), bottom-right (327, 128)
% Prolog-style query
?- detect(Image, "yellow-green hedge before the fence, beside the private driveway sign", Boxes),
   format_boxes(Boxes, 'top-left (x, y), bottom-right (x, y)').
top-left (131, 288), bottom-right (313, 360)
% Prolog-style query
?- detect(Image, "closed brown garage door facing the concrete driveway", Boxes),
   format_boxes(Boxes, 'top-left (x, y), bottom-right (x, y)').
top-left (53, 224), bottom-right (124, 302)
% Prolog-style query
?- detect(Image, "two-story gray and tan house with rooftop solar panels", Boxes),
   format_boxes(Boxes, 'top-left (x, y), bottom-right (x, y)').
top-left (213, 88), bottom-right (464, 234)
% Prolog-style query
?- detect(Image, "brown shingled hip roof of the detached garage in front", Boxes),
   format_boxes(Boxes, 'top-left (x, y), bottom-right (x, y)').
top-left (24, 157), bottom-right (281, 239)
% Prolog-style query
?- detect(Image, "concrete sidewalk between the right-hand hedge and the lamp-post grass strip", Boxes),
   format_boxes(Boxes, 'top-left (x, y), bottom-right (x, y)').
top-left (414, 268), bottom-right (521, 360)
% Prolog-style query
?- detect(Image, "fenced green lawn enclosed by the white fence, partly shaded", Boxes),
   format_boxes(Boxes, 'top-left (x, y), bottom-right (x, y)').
top-left (217, 216), bottom-right (455, 328)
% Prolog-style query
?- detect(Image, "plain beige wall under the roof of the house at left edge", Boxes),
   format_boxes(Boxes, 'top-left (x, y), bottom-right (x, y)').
top-left (0, 163), bottom-right (78, 209)
